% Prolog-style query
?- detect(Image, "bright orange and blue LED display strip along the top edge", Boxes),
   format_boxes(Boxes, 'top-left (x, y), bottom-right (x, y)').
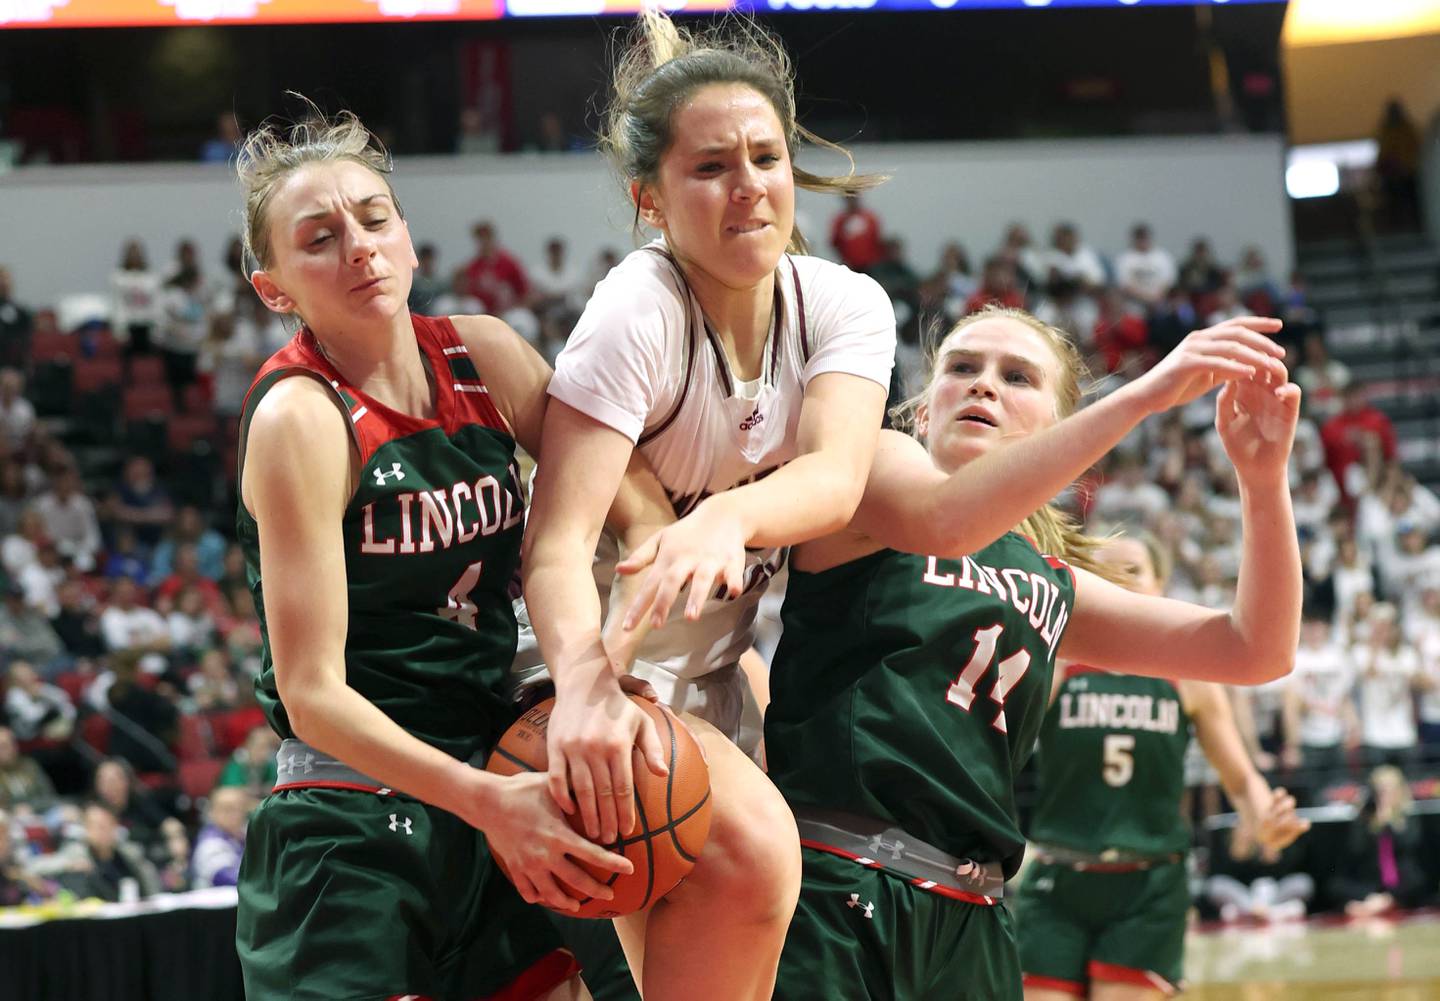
top-left (0, 0), bottom-right (1280, 29)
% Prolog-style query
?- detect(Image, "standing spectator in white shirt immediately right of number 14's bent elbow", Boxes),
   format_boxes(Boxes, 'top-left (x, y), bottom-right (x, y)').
top-left (1284, 618), bottom-right (1359, 785)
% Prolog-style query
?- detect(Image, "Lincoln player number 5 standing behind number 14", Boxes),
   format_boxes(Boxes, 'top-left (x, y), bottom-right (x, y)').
top-left (1015, 539), bottom-right (1309, 1001)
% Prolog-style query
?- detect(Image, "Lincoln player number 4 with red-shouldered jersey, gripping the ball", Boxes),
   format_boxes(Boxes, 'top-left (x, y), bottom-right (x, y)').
top-left (228, 103), bottom-right (653, 1001)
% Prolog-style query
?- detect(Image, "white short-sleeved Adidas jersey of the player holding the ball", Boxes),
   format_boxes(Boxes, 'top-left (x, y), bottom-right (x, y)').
top-left (541, 241), bottom-right (896, 685)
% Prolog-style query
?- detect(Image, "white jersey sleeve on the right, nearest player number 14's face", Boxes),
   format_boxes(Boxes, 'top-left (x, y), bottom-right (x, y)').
top-left (801, 265), bottom-right (896, 390)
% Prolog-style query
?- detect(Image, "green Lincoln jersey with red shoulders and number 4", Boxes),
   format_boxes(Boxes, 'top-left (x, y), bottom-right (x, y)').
top-left (238, 315), bottom-right (524, 759)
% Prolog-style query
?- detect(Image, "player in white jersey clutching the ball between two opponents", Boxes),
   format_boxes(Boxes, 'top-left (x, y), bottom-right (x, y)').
top-left (524, 13), bottom-right (894, 1001)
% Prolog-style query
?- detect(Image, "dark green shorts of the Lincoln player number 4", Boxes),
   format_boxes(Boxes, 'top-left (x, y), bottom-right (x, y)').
top-left (236, 788), bottom-right (576, 1001)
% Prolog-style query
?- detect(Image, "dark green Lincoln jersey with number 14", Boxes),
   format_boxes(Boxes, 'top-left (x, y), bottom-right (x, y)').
top-left (765, 533), bottom-right (1074, 873)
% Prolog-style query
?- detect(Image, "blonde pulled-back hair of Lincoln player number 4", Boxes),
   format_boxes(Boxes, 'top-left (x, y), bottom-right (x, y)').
top-left (235, 92), bottom-right (405, 279)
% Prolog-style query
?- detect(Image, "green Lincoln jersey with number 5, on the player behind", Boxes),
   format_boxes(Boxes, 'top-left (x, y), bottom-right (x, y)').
top-left (1030, 667), bottom-right (1189, 856)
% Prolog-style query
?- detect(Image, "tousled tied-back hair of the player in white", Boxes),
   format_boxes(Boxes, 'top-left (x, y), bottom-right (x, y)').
top-left (599, 10), bottom-right (888, 253)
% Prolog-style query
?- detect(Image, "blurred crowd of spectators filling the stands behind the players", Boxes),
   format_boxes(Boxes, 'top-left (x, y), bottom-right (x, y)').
top-left (0, 199), bottom-right (1440, 906)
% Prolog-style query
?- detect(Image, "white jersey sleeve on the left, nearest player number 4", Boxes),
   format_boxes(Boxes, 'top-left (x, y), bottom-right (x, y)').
top-left (550, 265), bottom-right (685, 441)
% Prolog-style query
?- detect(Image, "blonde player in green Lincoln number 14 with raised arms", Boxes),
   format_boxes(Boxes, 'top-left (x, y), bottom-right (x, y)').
top-left (766, 310), bottom-right (1300, 1000)
